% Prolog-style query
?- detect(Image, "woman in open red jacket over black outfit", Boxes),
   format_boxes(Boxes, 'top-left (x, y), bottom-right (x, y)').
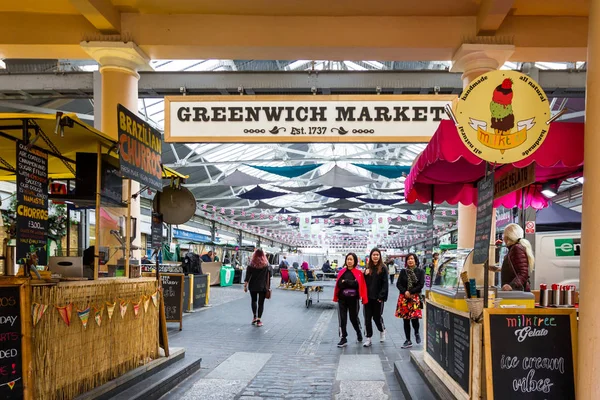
top-left (333, 253), bottom-right (369, 347)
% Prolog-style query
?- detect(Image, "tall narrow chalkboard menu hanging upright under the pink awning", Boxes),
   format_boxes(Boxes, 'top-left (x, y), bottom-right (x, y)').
top-left (473, 173), bottom-right (494, 264)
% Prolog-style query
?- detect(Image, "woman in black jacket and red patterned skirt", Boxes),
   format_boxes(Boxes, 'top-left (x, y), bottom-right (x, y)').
top-left (396, 253), bottom-right (425, 349)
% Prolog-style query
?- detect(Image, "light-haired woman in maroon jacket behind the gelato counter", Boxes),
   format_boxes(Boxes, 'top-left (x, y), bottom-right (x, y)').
top-left (500, 224), bottom-right (535, 292)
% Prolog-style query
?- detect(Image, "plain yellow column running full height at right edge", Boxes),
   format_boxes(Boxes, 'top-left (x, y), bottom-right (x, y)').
top-left (576, 0), bottom-right (600, 400)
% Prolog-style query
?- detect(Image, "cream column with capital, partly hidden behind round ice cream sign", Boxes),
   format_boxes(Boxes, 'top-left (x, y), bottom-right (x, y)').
top-left (451, 44), bottom-right (514, 278)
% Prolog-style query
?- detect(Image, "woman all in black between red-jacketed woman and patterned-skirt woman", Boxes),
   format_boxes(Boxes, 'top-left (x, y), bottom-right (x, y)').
top-left (363, 248), bottom-right (389, 347)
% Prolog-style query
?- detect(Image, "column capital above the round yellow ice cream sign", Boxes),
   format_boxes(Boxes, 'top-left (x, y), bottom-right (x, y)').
top-left (450, 43), bottom-right (515, 76)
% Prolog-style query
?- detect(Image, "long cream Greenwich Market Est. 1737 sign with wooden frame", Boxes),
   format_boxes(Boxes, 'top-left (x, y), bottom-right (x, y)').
top-left (165, 95), bottom-right (456, 143)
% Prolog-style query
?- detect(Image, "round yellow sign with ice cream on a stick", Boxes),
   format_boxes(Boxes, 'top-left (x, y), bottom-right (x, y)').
top-left (455, 71), bottom-right (551, 164)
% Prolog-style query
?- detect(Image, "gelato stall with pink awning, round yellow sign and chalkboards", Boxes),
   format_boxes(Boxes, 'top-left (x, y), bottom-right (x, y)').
top-left (405, 71), bottom-right (584, 399)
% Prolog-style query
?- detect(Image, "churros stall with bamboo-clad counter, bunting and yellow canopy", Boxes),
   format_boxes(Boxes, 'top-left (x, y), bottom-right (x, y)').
top-left (0, 113), bottom-right (163, 399)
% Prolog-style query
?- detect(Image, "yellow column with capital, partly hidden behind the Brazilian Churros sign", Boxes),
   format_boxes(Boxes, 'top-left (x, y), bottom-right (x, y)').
top-left (81, 42), bottom-right (151, 259)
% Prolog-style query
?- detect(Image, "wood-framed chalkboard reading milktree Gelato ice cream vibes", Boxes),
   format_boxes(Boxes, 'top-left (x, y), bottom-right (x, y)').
top-left (483, 309), bottom-right (577, 400)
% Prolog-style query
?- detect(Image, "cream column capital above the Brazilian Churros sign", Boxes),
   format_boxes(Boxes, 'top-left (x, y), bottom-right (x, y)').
top-left (81, 42), bottom-right (152, 78)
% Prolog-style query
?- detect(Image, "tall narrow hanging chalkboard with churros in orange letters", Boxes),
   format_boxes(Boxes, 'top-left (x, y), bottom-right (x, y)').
top-left (16, 141), bottom-right (48, 265)
